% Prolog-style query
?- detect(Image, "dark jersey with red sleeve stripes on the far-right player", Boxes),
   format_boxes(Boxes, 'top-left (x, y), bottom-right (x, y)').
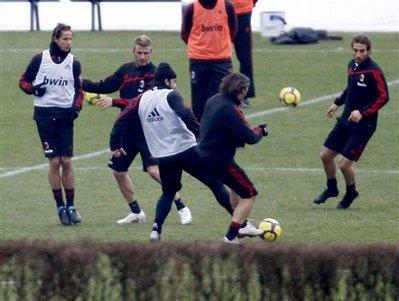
top-left (335, 58), bottom-right (389, 126)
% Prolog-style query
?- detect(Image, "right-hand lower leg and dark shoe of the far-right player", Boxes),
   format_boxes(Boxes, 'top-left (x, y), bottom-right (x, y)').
top-left (337, 157), bottom-right (359, 209)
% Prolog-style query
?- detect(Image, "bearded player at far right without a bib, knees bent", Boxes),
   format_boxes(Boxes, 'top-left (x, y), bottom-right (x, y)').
top-left (314, 35), bottom-right (389, 209)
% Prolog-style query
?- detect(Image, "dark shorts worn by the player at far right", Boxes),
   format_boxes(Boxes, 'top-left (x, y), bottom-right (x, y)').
top-left (324, 120), bottom-right (375, 161)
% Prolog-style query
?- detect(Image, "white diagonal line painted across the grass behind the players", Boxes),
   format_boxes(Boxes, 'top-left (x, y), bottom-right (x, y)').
top-left (0, 79), bottom-right (399, 179)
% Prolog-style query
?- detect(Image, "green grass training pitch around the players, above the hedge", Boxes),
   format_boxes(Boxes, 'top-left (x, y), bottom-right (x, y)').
top-left (0, 32), bottom-right (399, 244)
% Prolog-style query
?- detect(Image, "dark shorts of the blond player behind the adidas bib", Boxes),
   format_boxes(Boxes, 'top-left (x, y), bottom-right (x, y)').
top-left (108, 141), bottom-right (158, 172)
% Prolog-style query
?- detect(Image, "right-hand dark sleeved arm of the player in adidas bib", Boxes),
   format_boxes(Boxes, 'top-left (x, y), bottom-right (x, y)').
top-left (166, 91), bottom-right (199, 138)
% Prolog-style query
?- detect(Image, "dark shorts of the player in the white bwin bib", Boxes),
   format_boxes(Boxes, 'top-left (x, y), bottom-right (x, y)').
top-left (36, 118), bottom-right (73, 158)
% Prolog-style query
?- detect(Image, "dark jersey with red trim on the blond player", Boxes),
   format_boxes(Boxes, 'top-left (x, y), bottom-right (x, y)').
top-left (83, 62), bottom-right (156, 109)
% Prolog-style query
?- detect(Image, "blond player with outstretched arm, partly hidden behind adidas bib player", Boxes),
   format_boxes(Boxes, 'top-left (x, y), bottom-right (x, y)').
top-left (83, 35), bottom-right (192, 224)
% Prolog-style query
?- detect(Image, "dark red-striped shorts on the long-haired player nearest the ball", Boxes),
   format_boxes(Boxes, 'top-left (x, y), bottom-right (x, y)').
top-left (210, 162), bottom-right (258, 199)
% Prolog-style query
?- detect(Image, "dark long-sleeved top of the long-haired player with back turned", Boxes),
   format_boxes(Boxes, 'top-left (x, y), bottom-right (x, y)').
top-left (199, 93), bottom-right (262, 165)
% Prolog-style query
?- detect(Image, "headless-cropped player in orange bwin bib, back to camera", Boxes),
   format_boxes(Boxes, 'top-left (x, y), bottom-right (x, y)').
top-left (181, 0), bottom-right (237, 120)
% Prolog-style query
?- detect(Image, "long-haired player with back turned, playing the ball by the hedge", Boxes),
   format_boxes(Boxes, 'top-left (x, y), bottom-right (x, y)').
top-left (198, 73), bottom-right (268, 243)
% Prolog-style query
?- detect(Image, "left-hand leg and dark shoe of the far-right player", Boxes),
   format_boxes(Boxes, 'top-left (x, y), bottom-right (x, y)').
top-left (314, 146), bottom-right (339, 204)
